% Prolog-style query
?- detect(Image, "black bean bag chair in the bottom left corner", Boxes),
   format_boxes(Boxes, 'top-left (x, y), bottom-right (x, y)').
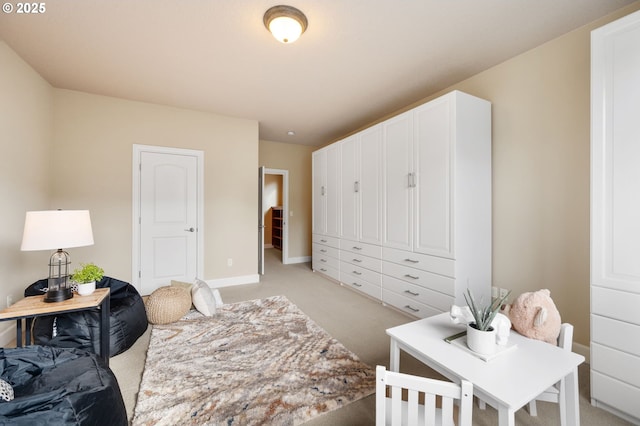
top-left (0, 346), bottom-right (127, 426)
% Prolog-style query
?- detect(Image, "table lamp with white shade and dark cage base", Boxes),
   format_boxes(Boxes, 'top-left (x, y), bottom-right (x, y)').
top-left (20, 210), bottom-right (93, 302)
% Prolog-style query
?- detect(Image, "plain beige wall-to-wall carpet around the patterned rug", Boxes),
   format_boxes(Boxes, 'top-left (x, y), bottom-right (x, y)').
top-left (111, 249), bottom-right (629, 426)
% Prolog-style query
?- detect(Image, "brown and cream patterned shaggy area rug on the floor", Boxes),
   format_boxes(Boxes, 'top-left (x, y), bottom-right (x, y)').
top-left (133, 296), bottom-right (375, 426)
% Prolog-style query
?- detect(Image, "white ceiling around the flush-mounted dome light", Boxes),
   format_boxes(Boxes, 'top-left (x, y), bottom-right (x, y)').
top-left (0, 0), bottom-right (634, 145)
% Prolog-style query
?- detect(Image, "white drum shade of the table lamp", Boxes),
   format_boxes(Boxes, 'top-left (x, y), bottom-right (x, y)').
top-left (20, 210), bottom-right (93, 251)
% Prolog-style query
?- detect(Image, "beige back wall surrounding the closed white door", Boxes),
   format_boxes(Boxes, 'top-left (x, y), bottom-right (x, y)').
top-left (52, 89), bottom-right (258, 281)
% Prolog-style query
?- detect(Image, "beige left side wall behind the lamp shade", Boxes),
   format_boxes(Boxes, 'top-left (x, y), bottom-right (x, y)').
top-left (0, 41), bottom-right (52, 339)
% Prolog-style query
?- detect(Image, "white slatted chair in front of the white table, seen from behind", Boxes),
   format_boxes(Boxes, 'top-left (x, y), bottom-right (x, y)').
top-left (376, 365), bottom-right (473, 426)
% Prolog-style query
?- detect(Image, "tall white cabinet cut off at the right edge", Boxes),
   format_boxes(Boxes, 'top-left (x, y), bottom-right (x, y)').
top-left (591, 12), bottom-right (640, 424)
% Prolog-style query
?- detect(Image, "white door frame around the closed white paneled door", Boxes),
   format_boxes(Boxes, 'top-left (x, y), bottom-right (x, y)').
top-left (131, 144), bottom-right (204, 291)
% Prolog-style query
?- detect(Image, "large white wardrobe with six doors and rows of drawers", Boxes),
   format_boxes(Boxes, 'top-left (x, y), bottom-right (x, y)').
top-left (312, 91), bottom-right (491, 318)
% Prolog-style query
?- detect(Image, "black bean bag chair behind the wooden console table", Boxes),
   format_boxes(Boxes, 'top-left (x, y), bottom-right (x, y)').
top-left (24, 277), bottom-right (149, 356)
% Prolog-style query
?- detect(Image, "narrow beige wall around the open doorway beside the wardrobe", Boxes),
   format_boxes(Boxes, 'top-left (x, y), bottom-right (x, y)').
top-left (259, 140), bottom-right (317, 259)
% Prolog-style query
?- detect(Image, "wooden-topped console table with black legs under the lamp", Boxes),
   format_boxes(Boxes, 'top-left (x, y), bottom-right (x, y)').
top-left (0, 288), bottom-right (110, 365)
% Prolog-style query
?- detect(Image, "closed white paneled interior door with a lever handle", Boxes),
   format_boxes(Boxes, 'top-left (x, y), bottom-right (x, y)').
top-left (137, 146), bottom-right (202, 294)
